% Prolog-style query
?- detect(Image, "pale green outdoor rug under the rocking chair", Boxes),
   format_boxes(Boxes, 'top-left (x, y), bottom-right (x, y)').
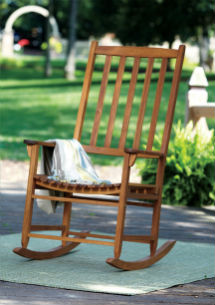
top-left (0, 230), bottom-right (214, 295)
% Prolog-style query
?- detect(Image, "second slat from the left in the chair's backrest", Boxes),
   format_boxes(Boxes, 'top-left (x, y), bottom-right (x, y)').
top-left (104, 56), bottom-right (126, 147)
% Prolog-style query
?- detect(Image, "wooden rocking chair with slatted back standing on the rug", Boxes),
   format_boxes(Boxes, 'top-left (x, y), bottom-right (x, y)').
top-left (13, 41), bottom-right (185, 270)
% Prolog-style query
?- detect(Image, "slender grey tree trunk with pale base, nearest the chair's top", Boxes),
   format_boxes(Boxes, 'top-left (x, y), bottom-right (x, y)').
top-left (64, 0), bottom-right (78, 80)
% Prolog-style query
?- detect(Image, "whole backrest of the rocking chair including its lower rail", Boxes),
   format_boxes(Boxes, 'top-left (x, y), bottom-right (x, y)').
top-left (74, 41), bottom-right (185, 155)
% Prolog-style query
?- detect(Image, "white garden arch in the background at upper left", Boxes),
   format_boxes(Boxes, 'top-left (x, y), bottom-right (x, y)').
top-left (1, 5), bottom-right (60, 57)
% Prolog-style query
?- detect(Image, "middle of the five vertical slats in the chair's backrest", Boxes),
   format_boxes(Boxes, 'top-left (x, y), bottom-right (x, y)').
top-left (119, 57), bottom-right (140, 148)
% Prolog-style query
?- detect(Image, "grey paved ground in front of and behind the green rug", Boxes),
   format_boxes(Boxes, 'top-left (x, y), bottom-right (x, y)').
top-left (0, 161), bottom-right (215, 305)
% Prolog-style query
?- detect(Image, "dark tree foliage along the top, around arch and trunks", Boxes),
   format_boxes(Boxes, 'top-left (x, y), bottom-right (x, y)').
top-left (0, 0), bottom-right (215, 45)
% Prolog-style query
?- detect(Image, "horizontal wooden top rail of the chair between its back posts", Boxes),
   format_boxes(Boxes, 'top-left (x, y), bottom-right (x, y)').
top-left (95, 46), bottom-right (178, 58)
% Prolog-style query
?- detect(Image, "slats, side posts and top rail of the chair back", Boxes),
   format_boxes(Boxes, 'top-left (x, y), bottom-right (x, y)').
top-left (74, 41), bottom-right (185, 154)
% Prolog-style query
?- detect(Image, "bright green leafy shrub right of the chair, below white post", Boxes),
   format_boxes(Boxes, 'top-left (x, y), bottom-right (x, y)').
top-left (138, 122), bottom-right (215, 206)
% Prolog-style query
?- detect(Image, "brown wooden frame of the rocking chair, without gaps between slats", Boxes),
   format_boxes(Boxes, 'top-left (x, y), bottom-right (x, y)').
top-left (15, 41), bottom-right (184, 270)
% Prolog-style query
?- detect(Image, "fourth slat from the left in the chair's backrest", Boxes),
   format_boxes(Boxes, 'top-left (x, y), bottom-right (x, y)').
top-left (133, 58), bottom-right (154, 149)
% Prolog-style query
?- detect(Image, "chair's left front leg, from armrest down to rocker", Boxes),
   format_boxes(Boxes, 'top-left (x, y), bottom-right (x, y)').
top-left (22, 145), bottom-right (39, 248)
